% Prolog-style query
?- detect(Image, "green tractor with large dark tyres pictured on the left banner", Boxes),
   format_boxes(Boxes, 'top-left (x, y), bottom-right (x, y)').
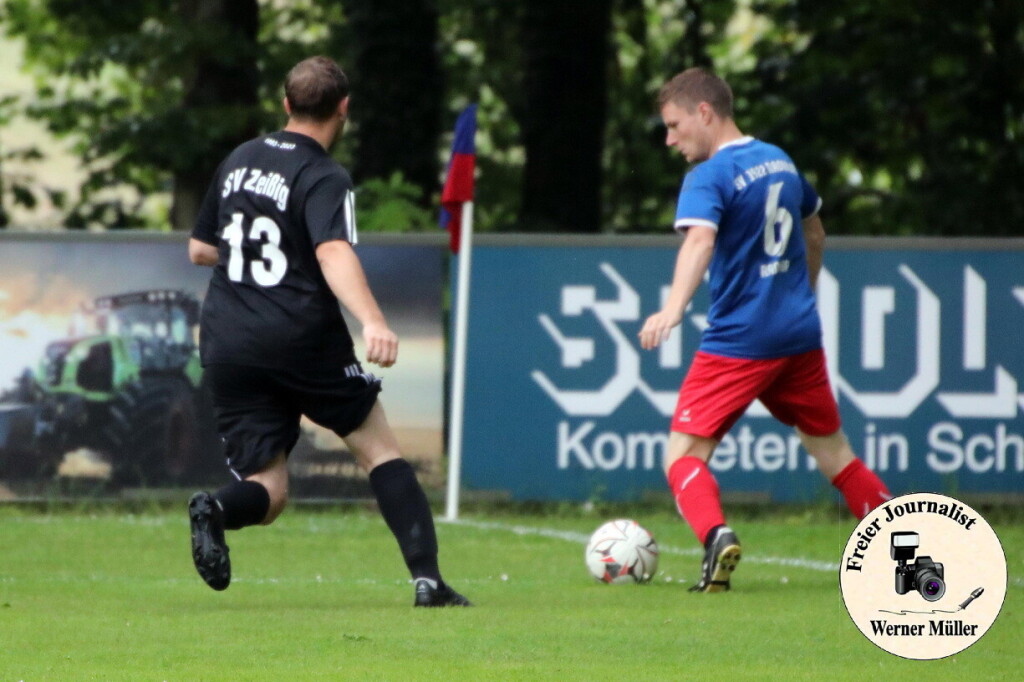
top-left (0, 290), bottom-right (218, 485)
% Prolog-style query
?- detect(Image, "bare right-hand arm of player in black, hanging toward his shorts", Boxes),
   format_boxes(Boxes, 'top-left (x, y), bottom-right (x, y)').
top-left (316, 240), bottom-right (398, 367)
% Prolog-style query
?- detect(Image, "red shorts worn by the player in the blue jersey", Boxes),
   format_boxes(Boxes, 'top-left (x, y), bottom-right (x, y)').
top-left (672, 349), bottom-right (841, 440)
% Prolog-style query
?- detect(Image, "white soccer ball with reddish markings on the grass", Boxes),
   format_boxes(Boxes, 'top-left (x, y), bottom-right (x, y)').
top-left (584, 518), bottom-right (657, 585)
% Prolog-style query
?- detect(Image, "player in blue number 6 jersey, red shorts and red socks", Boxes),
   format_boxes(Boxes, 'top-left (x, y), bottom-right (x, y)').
top-left (640, 69), bottom-right (890, 592)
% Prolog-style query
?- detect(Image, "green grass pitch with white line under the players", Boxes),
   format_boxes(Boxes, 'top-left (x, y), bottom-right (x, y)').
top-left (0, 500), bottom-right (1024, 682)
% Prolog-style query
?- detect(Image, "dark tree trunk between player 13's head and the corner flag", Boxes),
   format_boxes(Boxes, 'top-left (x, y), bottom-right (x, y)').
top-left (344, 0), bottom-right (443, 206)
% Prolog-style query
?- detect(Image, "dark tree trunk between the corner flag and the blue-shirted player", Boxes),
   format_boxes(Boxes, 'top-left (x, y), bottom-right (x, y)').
top-left (520, 0), bottom-right (611, 232)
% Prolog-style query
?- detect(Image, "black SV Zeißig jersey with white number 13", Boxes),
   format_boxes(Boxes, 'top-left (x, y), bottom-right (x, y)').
top-left (193, 131), bottom-right (355, 368)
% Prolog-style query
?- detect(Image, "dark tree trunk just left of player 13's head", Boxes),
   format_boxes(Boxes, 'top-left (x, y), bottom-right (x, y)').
top-left (171, 0), bottom-right (259, 230)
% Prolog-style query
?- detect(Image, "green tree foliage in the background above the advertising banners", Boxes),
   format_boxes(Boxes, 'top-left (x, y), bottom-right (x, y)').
top-left (0, 0), bottom-right (1024, 236)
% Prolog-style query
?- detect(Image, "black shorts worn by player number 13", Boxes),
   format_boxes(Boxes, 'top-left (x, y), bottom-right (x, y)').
top-left (205, 363), bottom-right (381, 478)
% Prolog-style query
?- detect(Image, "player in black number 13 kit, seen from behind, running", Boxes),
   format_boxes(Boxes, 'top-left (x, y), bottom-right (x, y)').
top-left (188, 56), bottom-right (470, 606)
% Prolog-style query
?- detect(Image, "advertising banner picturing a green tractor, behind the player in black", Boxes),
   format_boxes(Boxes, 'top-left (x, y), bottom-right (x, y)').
top-left (0, 230), bottom-right (444, 493)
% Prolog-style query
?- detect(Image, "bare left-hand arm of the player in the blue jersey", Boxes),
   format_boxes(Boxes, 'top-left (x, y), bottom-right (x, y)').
top-left (640, 225), bottom-right (716, 350)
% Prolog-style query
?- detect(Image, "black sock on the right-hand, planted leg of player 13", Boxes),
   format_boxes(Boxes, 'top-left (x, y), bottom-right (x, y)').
top-left (370, 459), bottom-right (443, 585)
